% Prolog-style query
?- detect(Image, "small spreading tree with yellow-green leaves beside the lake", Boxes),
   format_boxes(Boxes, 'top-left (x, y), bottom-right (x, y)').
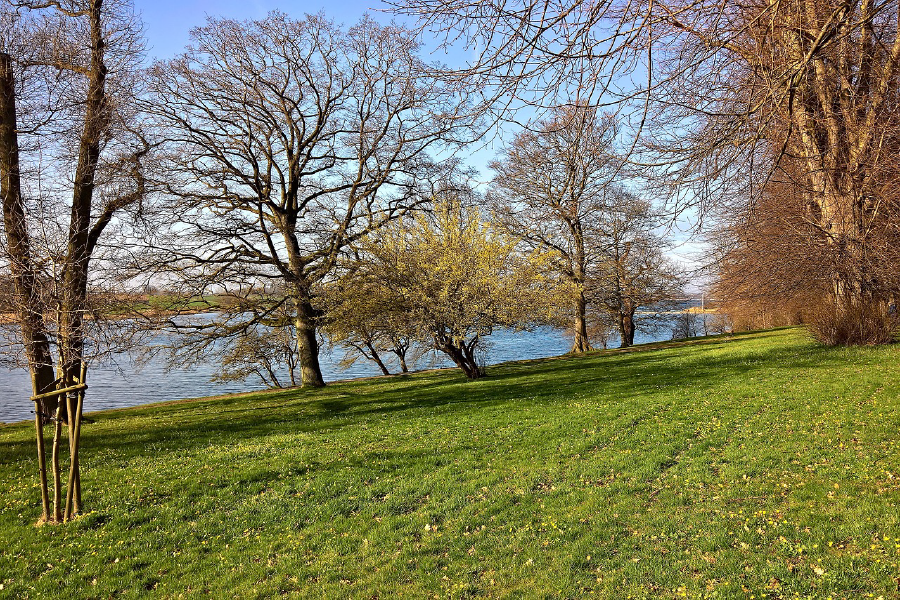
top-left (334, 197), bottom-right (566, 379)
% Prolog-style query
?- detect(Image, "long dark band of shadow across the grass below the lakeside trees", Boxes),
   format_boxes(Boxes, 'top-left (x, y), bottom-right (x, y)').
top-left (0, 331), bottom-right (838, 464)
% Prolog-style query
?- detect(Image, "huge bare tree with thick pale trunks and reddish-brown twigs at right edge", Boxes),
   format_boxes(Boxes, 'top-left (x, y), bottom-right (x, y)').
top-left (661, 1), bottom-right (900, 343)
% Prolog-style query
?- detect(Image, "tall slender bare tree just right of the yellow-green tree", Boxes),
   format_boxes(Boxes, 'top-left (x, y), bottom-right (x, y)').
top-left (489, 106), bottom-right (622, 352)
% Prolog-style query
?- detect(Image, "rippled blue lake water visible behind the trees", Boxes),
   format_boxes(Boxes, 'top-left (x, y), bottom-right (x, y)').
top-left (0, 328), bottom-right (671, 423)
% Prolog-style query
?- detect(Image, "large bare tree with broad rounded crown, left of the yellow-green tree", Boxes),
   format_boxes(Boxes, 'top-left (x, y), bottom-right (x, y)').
top-left (144, 13), bottom-right (468, 386)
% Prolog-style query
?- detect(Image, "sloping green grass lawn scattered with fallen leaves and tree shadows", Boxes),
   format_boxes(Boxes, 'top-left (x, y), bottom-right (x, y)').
top-left (0, 330), bottom-right (900, 599)
